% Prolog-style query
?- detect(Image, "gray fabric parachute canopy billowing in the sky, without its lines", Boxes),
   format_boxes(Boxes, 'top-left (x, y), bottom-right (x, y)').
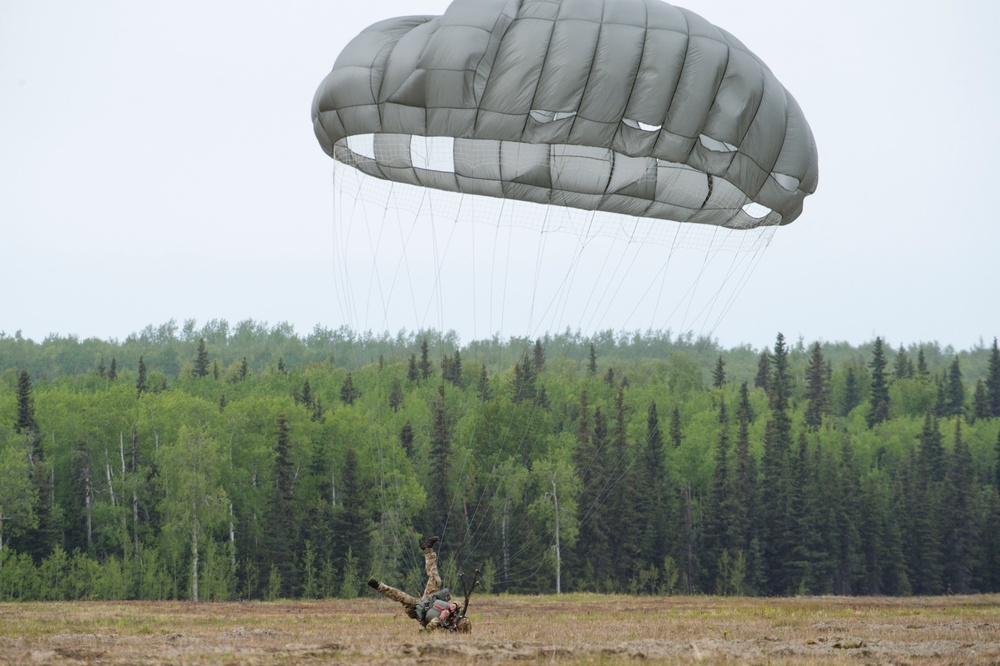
top-left (312, 0), bottom-right (818, 228)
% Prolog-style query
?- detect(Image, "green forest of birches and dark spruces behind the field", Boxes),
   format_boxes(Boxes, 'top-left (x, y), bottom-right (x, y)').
top-left (0, 320), bottom-right (1000, 601)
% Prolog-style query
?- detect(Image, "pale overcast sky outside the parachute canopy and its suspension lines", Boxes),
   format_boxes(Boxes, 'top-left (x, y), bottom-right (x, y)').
top-left (0, 0), bottom-right (1000, 349)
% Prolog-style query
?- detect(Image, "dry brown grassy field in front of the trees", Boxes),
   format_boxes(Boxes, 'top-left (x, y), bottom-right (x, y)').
top-left (0, 594), bottom-right (1000, 665)
